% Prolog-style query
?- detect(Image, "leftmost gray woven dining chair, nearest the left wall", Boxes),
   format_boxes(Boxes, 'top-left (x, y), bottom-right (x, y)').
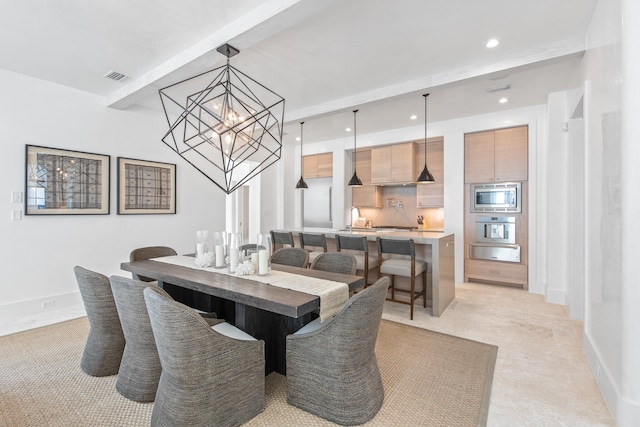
top-left (73, 266), bottom-right (125, 377)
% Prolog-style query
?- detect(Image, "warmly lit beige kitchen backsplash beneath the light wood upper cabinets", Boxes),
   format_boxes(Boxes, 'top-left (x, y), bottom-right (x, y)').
top-left (360, 186), bottom-right (444, 229)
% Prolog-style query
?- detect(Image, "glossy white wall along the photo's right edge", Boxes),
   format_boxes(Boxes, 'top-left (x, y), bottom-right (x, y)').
top-left (582, 0), bottom-right (640, 426)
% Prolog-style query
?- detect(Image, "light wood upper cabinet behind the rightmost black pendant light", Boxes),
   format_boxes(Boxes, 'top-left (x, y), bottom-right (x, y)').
top-left (414, 136), bottom-right (444, 208)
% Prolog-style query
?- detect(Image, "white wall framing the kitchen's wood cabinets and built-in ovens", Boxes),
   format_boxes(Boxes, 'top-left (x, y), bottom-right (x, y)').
top-left (283, 106), bottom-right (547, 293)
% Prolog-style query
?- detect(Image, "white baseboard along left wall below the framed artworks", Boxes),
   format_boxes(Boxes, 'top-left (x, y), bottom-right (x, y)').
top-left (0, 292), bottom-right (86, 336)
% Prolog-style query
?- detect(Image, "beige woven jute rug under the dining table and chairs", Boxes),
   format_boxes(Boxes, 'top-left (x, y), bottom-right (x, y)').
top-left (0, 317), bottom-right (498, 427)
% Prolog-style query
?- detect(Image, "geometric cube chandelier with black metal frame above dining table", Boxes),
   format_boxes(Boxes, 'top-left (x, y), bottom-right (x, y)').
top-left (159, 44), bottom-right (284, 194)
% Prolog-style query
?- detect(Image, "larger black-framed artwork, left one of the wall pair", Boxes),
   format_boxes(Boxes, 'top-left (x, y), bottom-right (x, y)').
top-left (25, 145), bottom-right (111, 215)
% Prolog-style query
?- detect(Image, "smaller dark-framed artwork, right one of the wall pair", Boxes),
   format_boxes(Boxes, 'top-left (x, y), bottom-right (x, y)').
top-left (118, 157), bottom-right (176, 215)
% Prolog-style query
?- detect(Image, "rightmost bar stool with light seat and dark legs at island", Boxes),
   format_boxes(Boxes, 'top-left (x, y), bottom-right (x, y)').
top-left (376, 237), bottom-right (428, 320)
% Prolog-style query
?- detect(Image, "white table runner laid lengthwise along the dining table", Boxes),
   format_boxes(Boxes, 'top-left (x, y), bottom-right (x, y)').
top-left (153, 255), bottom-right (349, 322)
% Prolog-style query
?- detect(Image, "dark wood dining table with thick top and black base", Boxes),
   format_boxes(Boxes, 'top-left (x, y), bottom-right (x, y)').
top-left (120, 260), bottom-right (364, 374)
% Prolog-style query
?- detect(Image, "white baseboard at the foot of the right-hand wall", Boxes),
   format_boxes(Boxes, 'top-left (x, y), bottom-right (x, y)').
top-left (584, 333), bottom-right (640, 427)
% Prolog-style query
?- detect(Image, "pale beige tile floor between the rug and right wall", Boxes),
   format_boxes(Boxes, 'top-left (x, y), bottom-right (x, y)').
top-left (383, 283), bottom-right (615, 427)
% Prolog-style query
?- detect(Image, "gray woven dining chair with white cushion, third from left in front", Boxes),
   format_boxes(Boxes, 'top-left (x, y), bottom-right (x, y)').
top-left (144, 286), bottom-right (265, 426)
